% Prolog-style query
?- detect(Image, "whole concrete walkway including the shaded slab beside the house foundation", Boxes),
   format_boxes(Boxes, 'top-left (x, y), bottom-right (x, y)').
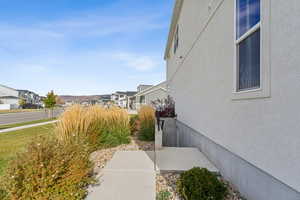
top-left (86, 147), bottom-right (219, 200)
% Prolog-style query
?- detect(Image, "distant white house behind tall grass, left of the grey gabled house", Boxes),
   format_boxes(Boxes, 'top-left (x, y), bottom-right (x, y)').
top-left (111, 91), bottom-right (137, 108)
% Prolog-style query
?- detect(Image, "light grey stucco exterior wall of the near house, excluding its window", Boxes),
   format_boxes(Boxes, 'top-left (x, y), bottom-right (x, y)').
top-left (166, 0), bottom-right (300, 200)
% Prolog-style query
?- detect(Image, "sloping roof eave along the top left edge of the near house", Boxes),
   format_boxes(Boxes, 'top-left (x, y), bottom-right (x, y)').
top-left (164, 0), bottom-right (184, 60)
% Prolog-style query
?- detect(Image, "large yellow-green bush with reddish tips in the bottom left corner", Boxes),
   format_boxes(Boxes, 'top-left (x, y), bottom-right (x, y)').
top-left (0, 138), bottom-right (93, 200)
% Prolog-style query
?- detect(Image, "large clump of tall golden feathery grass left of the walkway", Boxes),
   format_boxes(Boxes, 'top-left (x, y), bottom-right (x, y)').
top-left (55, 105), bottom-right (130, 149)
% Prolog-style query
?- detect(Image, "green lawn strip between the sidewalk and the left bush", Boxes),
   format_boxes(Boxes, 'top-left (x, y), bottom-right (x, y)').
top-left (0, 124), bottom-right (54, 176)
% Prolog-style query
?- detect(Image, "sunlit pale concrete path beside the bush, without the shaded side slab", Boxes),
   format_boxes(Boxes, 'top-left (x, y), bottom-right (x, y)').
top-left (86, 151), bottom-right (155, 200)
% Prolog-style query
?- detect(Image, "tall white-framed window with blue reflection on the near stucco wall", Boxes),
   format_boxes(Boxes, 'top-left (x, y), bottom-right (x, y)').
top-left (235, 0), bottom-right (261, 92)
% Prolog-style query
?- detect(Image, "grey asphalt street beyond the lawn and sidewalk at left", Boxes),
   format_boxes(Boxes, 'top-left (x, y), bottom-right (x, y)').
top-left (0, 109), bottom-right (63, 125)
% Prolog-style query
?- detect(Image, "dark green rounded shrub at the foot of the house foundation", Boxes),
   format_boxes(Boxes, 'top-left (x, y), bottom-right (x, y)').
top-left (177, 168), bottom-right (227, 200)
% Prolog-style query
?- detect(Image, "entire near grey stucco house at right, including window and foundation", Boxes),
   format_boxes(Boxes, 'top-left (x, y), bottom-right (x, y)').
top-left (165, 0), bottom-right (300, 200)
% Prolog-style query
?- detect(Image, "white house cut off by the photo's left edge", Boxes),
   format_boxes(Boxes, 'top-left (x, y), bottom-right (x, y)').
top-left (0, 85), bottom-right (19, 110)
